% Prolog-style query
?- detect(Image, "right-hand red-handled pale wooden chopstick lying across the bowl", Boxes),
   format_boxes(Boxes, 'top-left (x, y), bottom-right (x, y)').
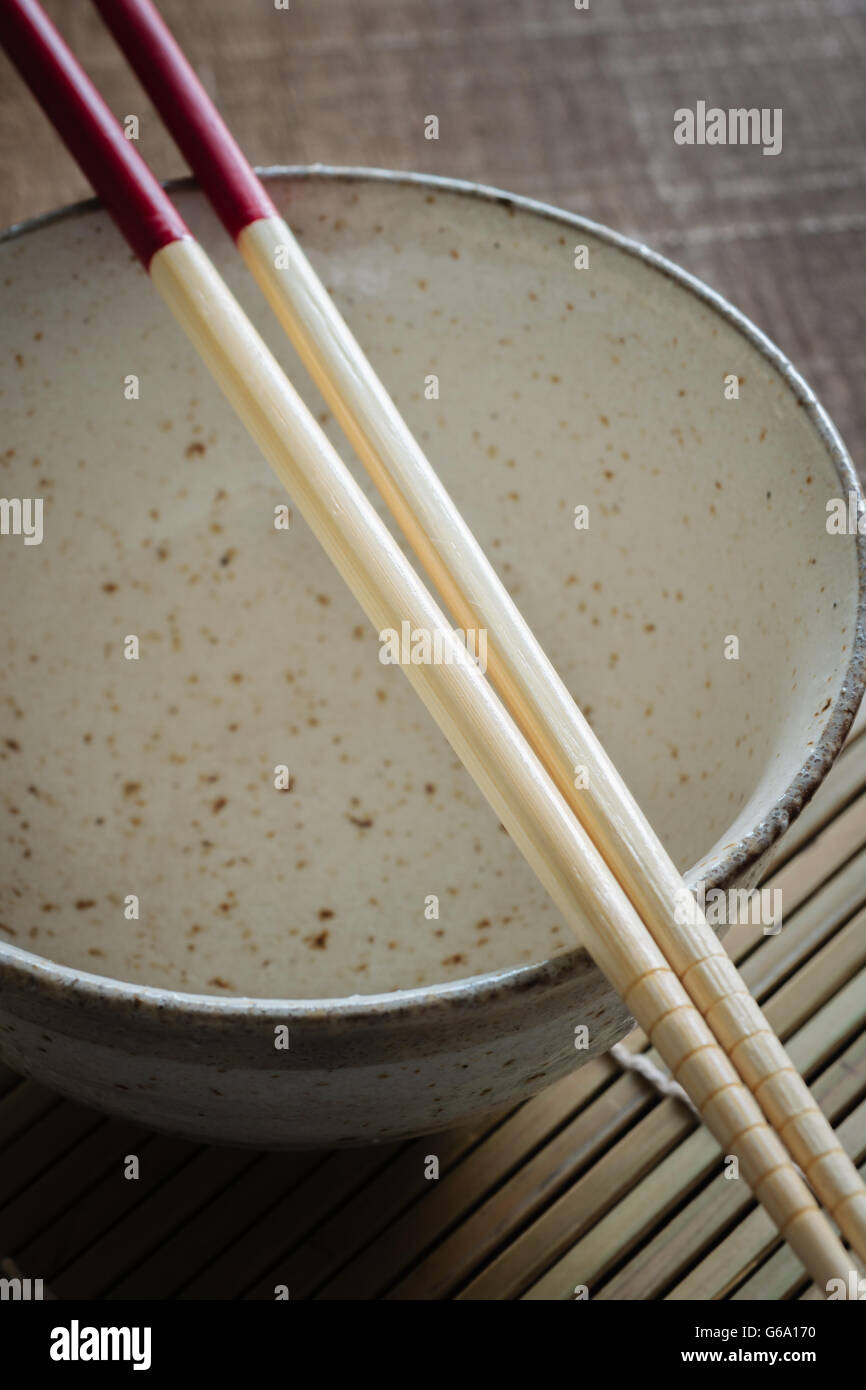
top-left (88, 0), bottom-right (866, 1261)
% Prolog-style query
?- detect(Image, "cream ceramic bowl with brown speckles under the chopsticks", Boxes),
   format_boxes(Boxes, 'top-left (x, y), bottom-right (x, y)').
top-left (0, 170), bottom-right (863, 1147)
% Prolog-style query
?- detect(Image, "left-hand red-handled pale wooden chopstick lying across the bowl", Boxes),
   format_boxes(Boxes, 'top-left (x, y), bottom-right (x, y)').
top-left (0, 0), bottom-right (851, 1290)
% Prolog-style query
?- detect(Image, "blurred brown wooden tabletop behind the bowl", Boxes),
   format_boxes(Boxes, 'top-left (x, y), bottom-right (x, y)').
top-left (0, 0), bottom-right (866, 478)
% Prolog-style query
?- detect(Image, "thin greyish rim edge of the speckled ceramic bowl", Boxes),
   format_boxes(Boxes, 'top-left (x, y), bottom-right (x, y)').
top-left (0, 163), bottom-right (866, 1023)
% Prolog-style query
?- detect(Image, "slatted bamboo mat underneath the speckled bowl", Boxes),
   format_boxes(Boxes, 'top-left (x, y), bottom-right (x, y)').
top-left (0, 706), bottom-right (866, 1301)
